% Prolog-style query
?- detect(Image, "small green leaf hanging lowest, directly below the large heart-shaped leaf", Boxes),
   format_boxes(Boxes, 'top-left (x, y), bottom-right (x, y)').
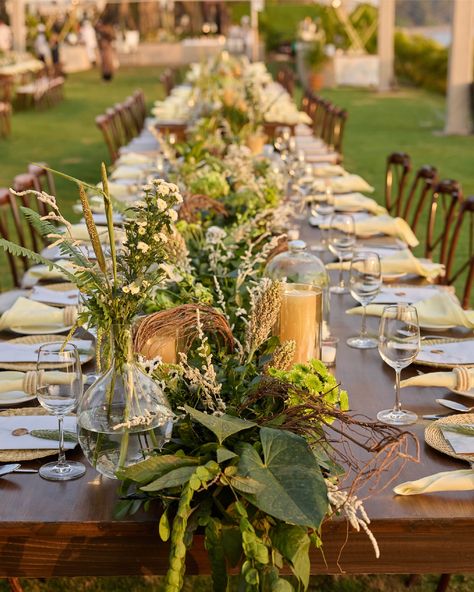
top-left (270, 524), bottom-right (311, 590)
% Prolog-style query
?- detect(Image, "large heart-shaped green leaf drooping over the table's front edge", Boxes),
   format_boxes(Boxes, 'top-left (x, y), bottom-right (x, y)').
top-left (238, 428), bottom-right (328, 528)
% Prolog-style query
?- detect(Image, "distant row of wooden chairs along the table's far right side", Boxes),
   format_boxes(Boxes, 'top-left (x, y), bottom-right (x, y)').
top-left (301, 91), bottom-right (348, 160)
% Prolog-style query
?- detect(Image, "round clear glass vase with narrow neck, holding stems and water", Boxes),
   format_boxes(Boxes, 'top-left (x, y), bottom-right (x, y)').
top-left (77, 327), bottom-right (173, 479)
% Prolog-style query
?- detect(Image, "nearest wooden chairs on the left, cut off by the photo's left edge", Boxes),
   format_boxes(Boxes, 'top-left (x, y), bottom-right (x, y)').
top-left (0, 163), bottom-right (56, 289)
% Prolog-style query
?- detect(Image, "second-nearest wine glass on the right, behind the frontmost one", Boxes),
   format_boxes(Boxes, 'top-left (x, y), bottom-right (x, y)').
top-left (347, 251), bottom-right (382, 349)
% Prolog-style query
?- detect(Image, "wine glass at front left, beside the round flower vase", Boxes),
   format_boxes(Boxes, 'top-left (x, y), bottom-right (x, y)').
top-left (36, 342), bottom-right (86, 481)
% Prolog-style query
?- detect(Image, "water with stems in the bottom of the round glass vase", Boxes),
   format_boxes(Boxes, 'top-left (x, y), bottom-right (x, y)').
top-left (77, 406), bottom-right (172, 479)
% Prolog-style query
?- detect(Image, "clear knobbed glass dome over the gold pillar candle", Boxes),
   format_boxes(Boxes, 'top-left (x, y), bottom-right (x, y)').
top-left (265, 240), bottom-right (330, 340)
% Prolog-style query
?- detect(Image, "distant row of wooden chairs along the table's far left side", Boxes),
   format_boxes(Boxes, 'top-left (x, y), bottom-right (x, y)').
top-left (95, 90), bottom-right (146, 162)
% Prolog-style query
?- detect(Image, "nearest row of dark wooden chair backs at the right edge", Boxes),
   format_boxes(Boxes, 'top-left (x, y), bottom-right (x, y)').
top-left (385, 152), bottom-right (474, 308)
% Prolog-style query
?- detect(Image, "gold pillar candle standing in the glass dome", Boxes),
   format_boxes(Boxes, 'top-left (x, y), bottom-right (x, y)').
top-left (278, 284), bottom-right (322, 364)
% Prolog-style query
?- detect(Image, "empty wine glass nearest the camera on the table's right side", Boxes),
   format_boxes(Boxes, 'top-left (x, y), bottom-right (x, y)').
top-left (377, 304), bottom-right (420, 425)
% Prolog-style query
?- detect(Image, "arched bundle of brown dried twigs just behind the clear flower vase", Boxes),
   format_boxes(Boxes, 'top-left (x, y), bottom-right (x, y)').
top-left (133, 304), bottom-right (234, 357)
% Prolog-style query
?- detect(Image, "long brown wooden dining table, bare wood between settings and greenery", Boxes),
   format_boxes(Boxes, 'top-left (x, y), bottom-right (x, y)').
top-left (0, 222), bottom-right (474, 577)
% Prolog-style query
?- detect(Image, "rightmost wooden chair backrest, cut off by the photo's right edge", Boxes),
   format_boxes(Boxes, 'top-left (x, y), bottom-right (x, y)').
top-left (443, 196), bottom-right (474, 308)
